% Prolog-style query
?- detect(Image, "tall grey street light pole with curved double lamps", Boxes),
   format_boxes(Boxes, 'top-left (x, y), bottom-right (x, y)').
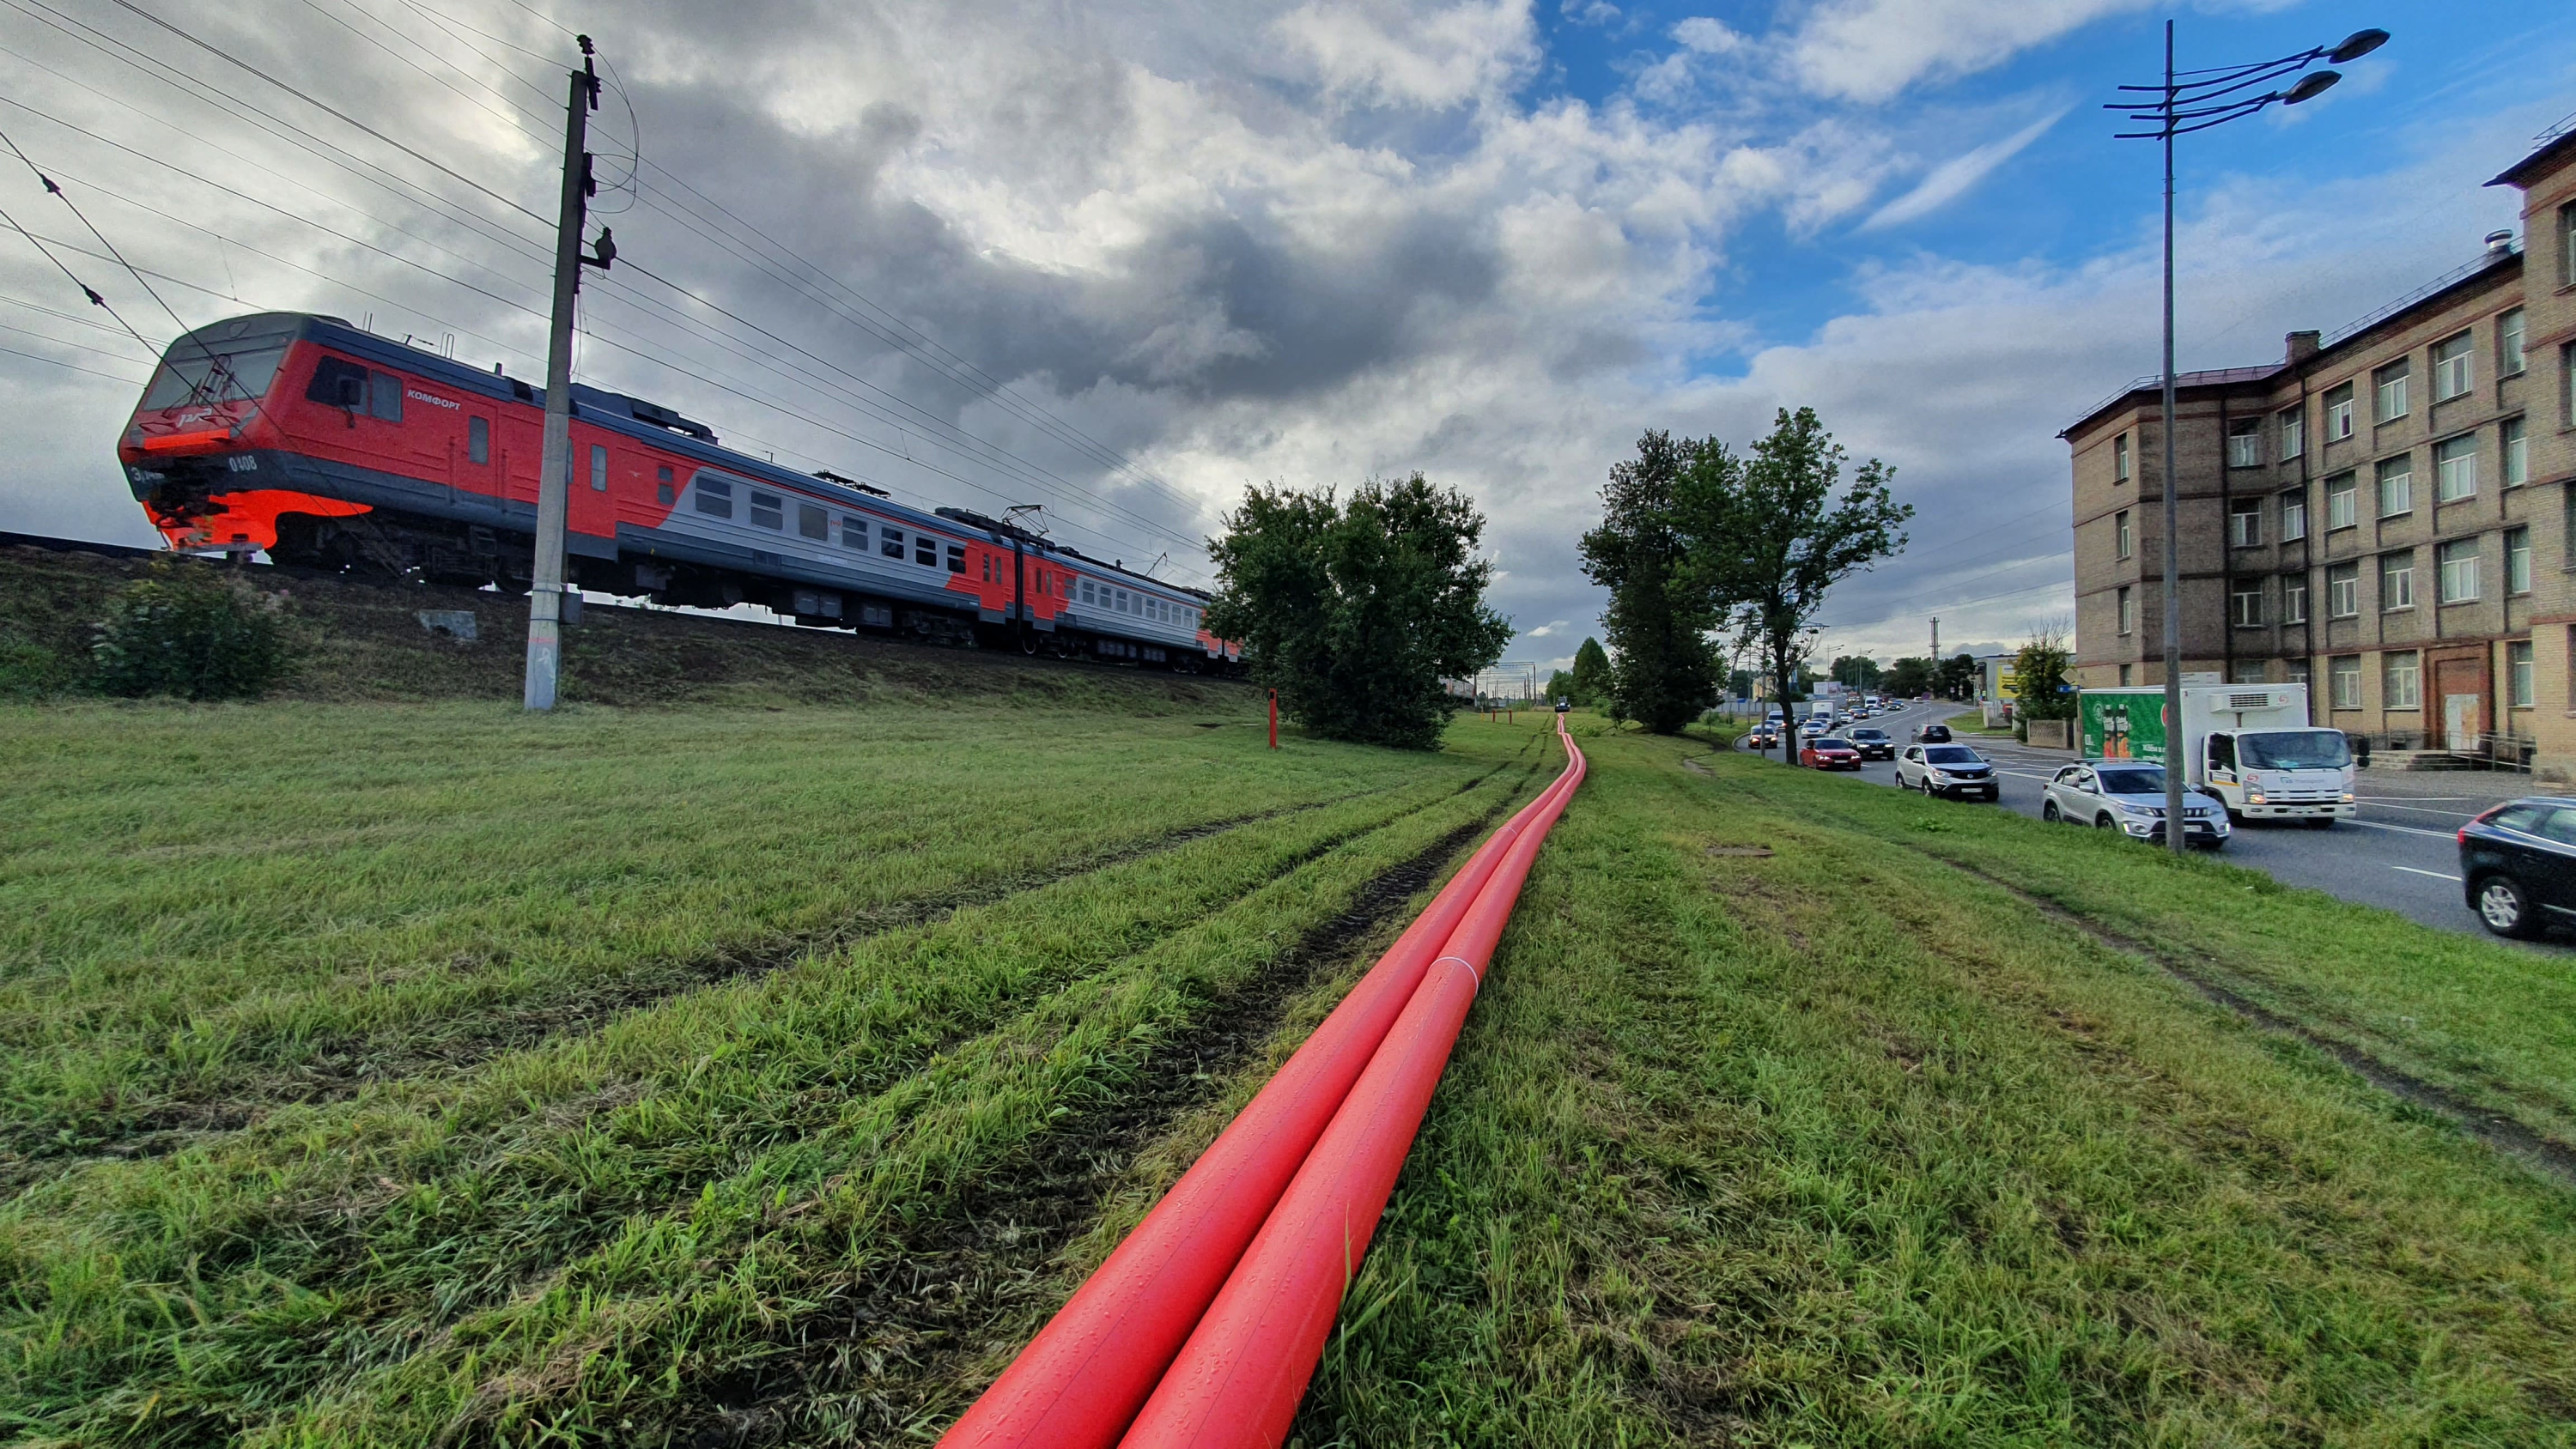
top-left (2105, 21), bottom-right (2388, 854)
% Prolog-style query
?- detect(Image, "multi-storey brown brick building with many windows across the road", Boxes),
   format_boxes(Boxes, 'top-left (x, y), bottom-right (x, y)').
top-left (2063, 129), bottom-right (2576, 777)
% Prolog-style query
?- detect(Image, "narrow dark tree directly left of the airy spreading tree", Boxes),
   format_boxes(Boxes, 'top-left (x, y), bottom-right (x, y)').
top-left (1582, 433), bottom-right (1718, 733)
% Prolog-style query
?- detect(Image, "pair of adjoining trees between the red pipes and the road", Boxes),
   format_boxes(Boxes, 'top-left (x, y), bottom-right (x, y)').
top-left (1582, 407), bottom-right (1914, 733)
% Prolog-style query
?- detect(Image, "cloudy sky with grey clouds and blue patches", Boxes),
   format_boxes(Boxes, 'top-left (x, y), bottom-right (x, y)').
top-left (0, 0), bottom-right (2576, 664)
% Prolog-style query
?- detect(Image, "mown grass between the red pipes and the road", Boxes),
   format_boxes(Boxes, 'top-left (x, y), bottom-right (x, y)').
top-left (1296, 720), bottom-right (2576, 1449)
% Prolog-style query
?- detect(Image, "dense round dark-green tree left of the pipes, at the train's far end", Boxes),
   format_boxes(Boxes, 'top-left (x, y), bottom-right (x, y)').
top-left (1206, 474), bottom-right (1512, 749)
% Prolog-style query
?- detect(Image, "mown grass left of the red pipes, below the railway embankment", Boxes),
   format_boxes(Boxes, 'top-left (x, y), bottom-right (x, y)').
top-left (0, 706), bottom-right (1540, 1444)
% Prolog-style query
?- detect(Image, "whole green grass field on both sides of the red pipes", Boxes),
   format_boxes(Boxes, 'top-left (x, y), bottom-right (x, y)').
top-left (0, 695), bottom-right (2576, 1449)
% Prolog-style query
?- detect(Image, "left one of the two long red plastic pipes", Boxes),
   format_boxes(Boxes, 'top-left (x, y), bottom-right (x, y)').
top-left (940, 743), bottom-right (1574, 1449)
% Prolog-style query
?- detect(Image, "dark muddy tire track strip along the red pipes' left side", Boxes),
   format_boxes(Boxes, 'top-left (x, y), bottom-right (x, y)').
top-left (647, 792), bottom-right (1538, 1449)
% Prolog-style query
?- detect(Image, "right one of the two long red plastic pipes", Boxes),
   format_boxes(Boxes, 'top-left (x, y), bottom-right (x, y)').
top-left (1118, 721), bottom-right (1584, 1449)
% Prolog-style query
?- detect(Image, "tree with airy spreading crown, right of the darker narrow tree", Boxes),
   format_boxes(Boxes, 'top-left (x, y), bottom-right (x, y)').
top-left (1677, 407), bottom-right (1914, 756)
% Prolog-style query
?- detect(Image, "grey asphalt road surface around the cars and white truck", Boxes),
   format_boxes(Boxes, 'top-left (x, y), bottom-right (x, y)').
top-left (1741, 703), bottom-right (2571, 949)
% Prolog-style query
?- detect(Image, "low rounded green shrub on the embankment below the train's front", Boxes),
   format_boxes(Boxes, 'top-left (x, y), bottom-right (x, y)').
top-left (90, 559), bottom-right (294, 700)
